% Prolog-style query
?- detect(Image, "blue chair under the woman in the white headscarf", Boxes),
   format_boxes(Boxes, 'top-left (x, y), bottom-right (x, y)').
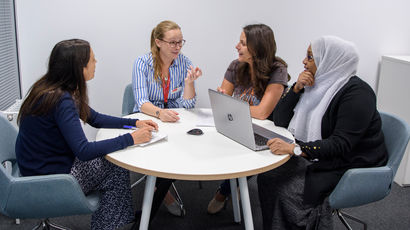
top-left (329, 112), bottom-right (410, 230)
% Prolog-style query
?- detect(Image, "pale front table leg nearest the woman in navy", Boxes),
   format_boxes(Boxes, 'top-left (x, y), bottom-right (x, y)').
top-left (140, 175), bottom-right (157, 230)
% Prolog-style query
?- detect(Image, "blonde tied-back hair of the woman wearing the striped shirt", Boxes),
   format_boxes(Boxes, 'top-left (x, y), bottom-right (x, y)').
top-left (151, 21), bottom-right (181, 81)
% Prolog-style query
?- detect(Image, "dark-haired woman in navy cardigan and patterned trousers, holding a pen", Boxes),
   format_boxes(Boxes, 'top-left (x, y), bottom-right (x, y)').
top-left (16, 39), bottom-right (171, 229)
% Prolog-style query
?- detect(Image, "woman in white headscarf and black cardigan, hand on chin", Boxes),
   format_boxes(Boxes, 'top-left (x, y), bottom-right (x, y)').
top-left (258, 36), bottom-right (387, 229)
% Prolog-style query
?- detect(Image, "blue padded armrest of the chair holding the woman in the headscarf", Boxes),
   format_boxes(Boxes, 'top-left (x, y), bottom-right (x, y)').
top-left (329, 166), bottom-right (393, 209)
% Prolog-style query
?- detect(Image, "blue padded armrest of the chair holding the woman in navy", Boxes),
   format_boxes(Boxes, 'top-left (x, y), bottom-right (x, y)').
top-left (7, 174), bottom-right (99, 218)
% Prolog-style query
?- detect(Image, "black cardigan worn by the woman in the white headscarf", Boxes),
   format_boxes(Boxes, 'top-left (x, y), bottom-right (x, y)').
top-left (272, 76), bottom-right (388, 204)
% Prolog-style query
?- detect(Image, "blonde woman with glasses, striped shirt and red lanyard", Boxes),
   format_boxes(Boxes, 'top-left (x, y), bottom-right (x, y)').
top-left (132, 21), bottom-right (202, 122)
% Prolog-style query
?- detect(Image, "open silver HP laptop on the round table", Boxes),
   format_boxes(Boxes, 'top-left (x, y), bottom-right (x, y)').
top-left (208, 89), bottom-right (294, 151)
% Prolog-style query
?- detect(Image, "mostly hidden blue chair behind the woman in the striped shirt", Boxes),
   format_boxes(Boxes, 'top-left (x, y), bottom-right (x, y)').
top-left (122, 84), bottom-right (186, 216)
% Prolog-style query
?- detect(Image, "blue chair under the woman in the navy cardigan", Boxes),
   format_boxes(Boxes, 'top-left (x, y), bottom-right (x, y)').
top-left (0, 116), bottom-right (99, 229)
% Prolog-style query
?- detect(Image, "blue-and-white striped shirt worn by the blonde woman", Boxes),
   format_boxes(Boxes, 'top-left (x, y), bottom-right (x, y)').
top-left (132, 53), bottom-right (196, 112)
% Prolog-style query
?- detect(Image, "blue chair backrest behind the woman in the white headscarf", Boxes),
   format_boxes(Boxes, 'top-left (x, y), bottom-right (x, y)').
top-left (380, 112), bottom-right (410, 178)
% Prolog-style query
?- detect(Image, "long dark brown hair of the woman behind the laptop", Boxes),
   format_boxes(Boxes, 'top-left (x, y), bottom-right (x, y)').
top-left (236, 24), bottom-right (290, 99)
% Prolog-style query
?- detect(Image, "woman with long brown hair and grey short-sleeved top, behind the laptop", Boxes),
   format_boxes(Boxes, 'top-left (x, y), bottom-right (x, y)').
top-left (208, 24), bottom-right (289, 214)
